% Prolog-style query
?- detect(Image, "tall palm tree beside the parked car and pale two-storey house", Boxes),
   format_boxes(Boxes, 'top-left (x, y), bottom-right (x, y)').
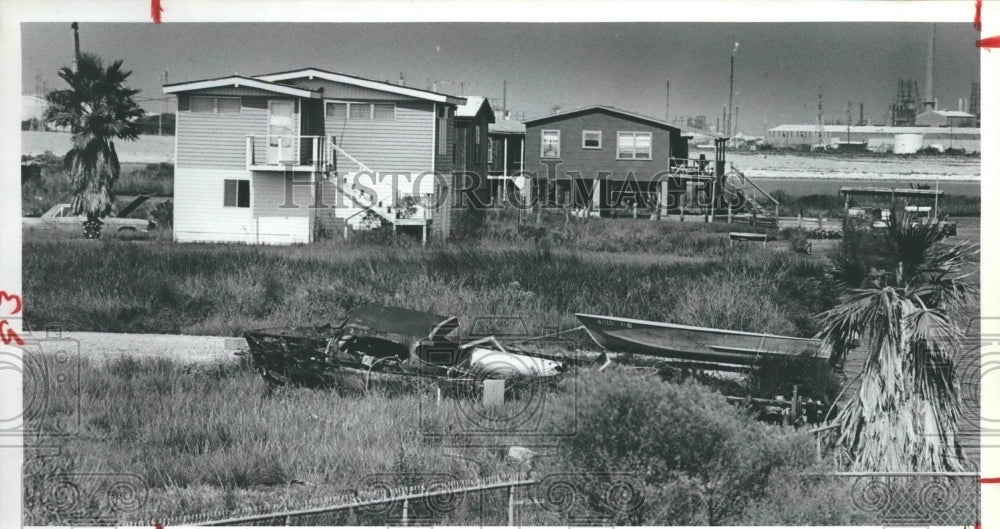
top-left (45, 53), bottom-right (144, 239)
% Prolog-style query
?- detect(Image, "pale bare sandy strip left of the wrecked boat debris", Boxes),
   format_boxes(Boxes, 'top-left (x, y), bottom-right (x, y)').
top-left (24, 331), bottom-right (242, 365)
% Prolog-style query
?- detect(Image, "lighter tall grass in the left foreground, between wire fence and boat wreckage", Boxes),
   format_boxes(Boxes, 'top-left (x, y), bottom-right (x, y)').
top-left (25, 357), bottom-right (524, 525)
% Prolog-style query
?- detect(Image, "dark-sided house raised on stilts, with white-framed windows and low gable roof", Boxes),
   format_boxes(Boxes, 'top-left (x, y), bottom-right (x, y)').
top-left (524, 106), bottom-right (691, 212)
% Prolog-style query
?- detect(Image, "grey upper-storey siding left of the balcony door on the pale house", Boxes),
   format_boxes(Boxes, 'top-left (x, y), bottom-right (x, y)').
top-left (175, 93), bottom-right (300, 169)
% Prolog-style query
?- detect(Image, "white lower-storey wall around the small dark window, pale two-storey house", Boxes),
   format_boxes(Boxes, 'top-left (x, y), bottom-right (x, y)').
top-left (174, 166), bottom-right (255, 243)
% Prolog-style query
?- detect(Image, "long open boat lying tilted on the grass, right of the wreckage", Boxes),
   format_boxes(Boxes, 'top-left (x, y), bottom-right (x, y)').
top-left (576, 314), bottom-right (829, 367)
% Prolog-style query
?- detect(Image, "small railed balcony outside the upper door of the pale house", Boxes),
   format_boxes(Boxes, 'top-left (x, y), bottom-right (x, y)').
top-left (246, 136), bottom-right (327, 172)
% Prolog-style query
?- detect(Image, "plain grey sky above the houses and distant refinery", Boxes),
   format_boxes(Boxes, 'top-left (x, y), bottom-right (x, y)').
top-left (22, 22), bottom-right (979, 134)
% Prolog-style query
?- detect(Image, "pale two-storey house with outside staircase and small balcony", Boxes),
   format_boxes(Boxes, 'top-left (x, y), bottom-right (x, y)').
top-left (163, 68), bottom-right (468, 244)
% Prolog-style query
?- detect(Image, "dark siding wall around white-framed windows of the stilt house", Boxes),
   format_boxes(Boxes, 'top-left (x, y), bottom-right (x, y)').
top-left (524, 112), bottom-right (679, 180)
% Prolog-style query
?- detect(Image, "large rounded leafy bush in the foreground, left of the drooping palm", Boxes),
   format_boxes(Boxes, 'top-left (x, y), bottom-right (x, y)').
top-left (543, 370), bottom-right (853, 525)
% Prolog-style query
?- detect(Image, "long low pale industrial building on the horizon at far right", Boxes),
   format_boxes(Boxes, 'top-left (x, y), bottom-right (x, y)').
top-left (767, 125), bottom-right (980, 152)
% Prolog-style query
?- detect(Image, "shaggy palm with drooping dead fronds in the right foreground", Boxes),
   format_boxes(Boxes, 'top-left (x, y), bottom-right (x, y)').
top-left (819, 212), bottom-right (976, 472)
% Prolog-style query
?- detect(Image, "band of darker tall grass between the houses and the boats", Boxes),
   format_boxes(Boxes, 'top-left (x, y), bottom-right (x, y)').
top-left (24, 225), bottom-right (832, 335)
